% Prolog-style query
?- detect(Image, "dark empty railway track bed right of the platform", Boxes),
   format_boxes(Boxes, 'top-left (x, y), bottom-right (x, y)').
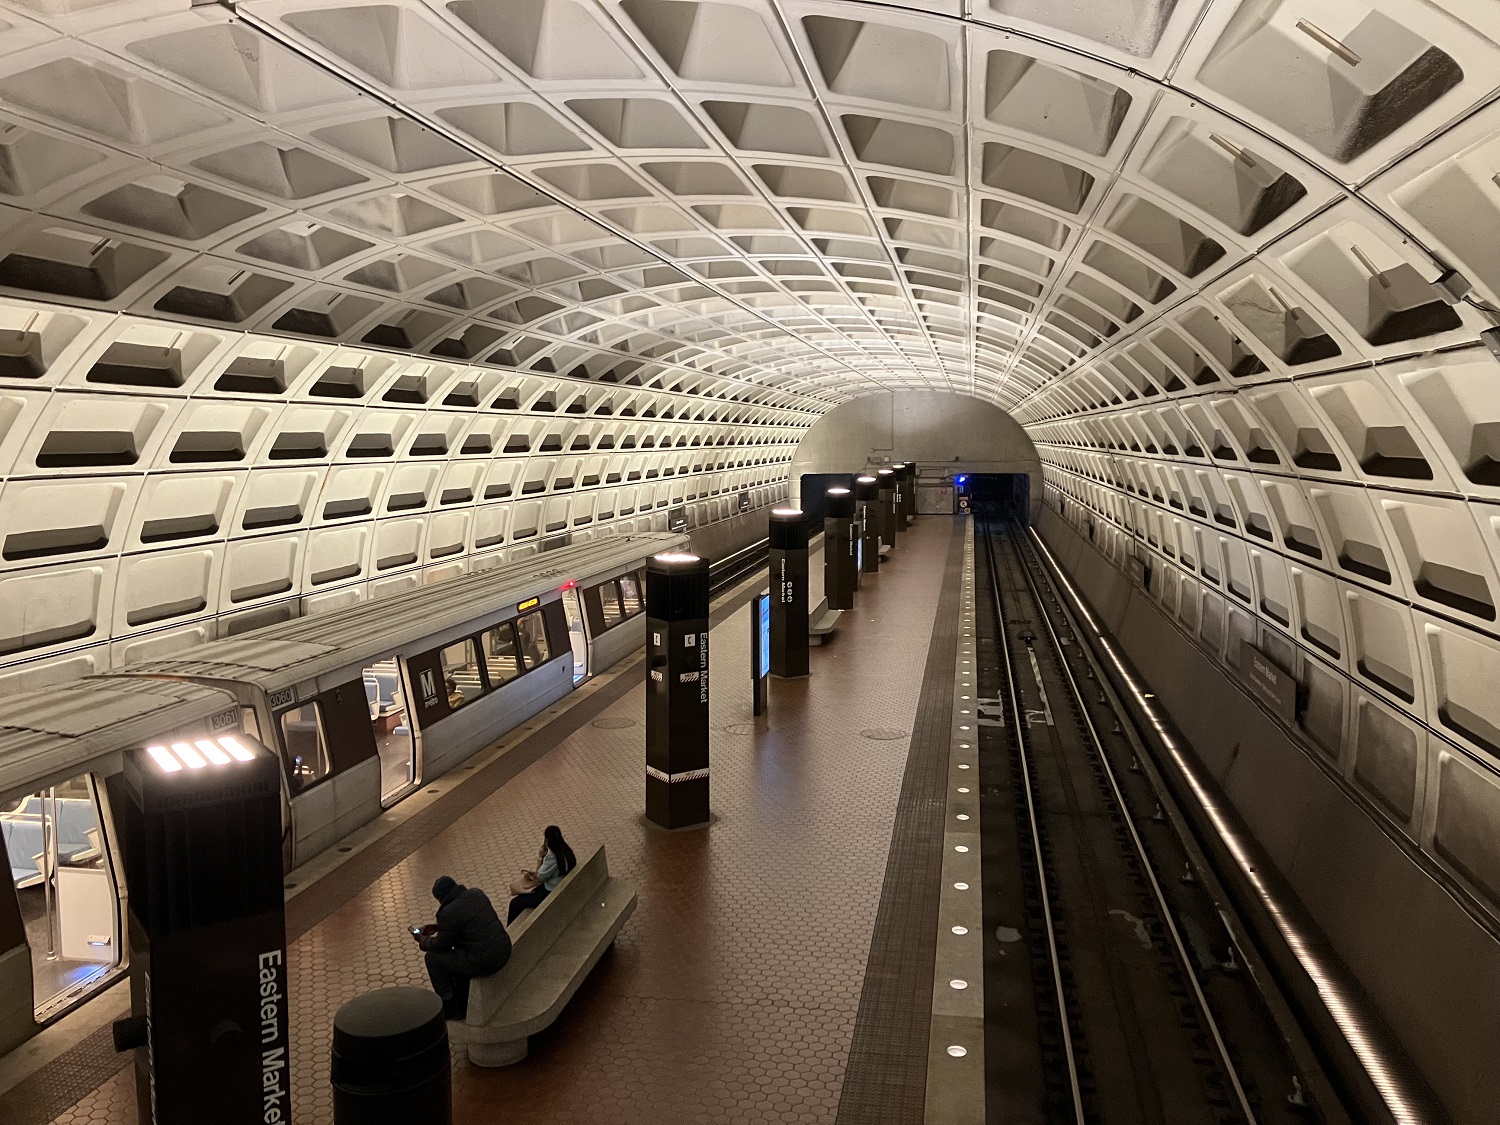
top-left (977, 524), bottom-right (1347, 1125)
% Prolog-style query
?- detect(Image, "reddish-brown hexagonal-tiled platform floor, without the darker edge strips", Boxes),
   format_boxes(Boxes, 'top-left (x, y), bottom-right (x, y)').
top-left (43, 519), bottom-right (956, 1125)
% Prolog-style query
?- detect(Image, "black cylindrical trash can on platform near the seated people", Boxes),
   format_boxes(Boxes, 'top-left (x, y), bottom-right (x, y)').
top-left (330, 989), bottom-right (453, 1125)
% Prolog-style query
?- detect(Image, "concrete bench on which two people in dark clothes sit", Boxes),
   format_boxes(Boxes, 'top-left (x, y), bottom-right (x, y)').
top-left (465, 846), bottom-right (636, 1067)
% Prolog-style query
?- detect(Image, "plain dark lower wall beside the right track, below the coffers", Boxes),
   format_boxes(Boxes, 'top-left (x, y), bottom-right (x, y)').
top-left (1038, 506), bottom-right (1500, 1125)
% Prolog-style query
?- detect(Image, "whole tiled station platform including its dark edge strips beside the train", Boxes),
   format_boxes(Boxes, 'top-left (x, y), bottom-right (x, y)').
top-left (0, 518), bottom-right (966, 1125)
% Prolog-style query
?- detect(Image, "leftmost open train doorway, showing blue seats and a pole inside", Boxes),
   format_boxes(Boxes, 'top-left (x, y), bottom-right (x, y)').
top-left (0, 774), bottom-right (122, 1020)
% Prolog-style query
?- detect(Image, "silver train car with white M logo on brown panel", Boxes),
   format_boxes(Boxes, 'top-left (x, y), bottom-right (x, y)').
top-left (129, 534), bottom-right (687, 869)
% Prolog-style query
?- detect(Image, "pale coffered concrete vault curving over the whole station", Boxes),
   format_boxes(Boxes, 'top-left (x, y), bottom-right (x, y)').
top-left (0, 0), bottom-right (1500, 1116)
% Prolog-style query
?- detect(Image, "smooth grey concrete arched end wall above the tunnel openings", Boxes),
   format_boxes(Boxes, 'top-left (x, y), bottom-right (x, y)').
top-left (789, 390), bottom-right (1043, 519)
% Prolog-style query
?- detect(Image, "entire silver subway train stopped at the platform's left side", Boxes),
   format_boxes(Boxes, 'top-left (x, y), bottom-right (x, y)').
top-left (0, 533), bottom-right (689, 1053)
